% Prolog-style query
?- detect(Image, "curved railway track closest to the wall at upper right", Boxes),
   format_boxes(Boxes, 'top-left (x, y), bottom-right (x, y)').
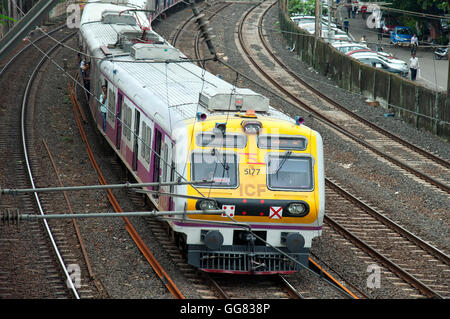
top-left (234, 1), bottom-right (450, 194)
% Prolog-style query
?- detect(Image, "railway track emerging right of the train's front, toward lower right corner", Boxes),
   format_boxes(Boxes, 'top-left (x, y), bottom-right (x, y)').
top-left (324, 179), bottom-right (450, 298)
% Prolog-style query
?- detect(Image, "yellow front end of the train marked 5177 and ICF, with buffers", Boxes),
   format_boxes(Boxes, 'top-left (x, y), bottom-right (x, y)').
top-left (173, 107), bottom-right (325, 274)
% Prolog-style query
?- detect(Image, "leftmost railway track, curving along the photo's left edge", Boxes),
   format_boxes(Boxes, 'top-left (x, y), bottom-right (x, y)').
top-left (0, 23), bottom-right (84, 298)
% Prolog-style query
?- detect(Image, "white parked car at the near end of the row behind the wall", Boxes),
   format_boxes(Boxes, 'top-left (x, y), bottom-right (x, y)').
top-left (347, 50), bottom-right (409, 77)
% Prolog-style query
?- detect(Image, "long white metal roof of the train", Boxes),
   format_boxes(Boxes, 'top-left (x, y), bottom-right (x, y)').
top-left (80, 0), bottom-right (295, 129)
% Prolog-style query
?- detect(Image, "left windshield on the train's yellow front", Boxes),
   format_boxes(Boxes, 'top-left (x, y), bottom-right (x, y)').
top-left (191, 149), bottom-right (238, 188)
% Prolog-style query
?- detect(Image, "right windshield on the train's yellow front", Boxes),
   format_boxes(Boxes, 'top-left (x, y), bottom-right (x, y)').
top-left (267, 155), bottom-right (314, 191)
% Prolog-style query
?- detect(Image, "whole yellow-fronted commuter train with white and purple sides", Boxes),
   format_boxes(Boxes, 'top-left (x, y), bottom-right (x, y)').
top-left (79, 0), bottom-right (325, 274)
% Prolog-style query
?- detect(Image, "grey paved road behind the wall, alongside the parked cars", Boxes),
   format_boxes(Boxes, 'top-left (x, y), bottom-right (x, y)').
top-left (337, 8), bottom-right (448, 91)
